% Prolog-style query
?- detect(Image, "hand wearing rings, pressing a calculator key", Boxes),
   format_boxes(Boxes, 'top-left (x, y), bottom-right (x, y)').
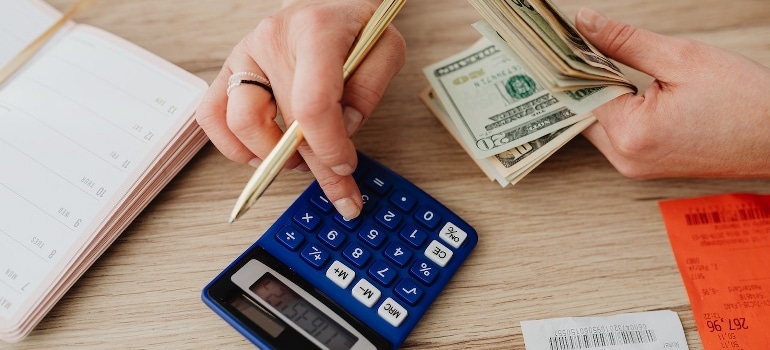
top-left (196, 0), bottom-right (406, 218)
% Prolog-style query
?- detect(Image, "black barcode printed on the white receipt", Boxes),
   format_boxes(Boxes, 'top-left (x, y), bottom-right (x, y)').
top-left (548, 330), bottom-right (658, 350)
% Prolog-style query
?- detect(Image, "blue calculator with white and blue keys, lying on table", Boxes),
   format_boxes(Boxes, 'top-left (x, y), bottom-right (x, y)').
top-left (202, 153), bottom-right (478, 350)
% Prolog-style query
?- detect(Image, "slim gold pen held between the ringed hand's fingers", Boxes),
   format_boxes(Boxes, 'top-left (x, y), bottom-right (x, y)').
top-left (230, 0), bottom-right (406, 223)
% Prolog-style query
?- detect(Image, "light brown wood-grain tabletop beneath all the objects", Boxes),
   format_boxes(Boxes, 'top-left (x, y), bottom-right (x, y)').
top-left (7, 0), bottom-right (770, 349)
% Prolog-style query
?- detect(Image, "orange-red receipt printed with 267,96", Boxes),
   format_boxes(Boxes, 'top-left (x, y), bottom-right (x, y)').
top-left (660, 194), bottom-right (770, 350)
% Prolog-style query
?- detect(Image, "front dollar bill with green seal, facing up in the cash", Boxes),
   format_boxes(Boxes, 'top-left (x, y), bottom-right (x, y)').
top-left (424, 34), bottom-right (630, 159)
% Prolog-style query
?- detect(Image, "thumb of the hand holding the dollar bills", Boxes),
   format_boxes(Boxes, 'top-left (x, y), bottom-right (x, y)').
top-left (575, 8), bottom-right (679, 80)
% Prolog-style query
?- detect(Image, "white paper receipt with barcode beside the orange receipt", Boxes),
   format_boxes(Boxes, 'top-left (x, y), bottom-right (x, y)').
top-left (521, 310), bottom-right (688, 350)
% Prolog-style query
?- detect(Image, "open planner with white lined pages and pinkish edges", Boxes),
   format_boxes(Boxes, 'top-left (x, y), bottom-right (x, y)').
top-left (0, 0), bottom-right (207, 341)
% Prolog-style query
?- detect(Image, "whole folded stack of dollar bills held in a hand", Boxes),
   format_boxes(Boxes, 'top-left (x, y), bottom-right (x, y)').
top-left (421, 0), bottom-right (636, 187)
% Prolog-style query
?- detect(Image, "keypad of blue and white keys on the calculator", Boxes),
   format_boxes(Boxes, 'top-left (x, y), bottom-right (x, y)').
top-left (274, 154), bottom-right (475, 334)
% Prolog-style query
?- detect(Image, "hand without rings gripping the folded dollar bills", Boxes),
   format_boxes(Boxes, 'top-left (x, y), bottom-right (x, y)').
top-left (575, 9), bottom-right (770, 179)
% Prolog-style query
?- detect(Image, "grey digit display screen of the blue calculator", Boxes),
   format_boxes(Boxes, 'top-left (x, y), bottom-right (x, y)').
top-left (250, 273), bottom-right (358, 350)
